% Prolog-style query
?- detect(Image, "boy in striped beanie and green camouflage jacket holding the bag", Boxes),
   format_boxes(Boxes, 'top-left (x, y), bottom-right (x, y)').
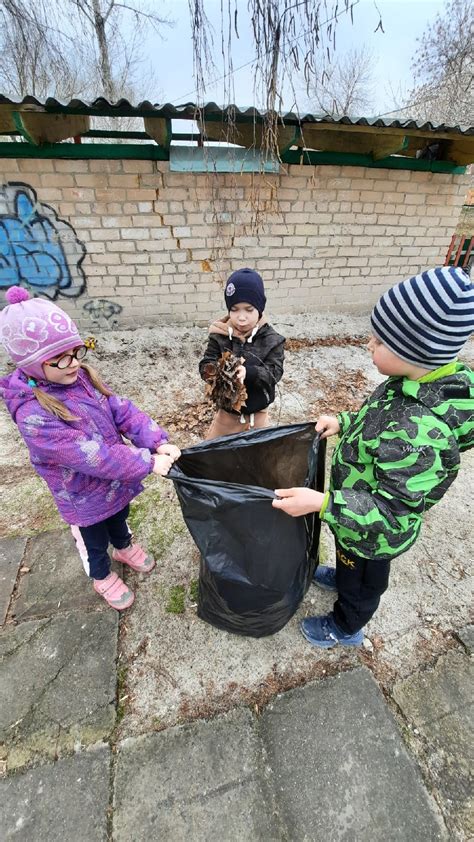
top-left (273, 267), bottom-right (474, 648)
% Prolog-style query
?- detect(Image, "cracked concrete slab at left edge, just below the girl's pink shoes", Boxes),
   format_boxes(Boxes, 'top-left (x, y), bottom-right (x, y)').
top-left (0, 610), bottom-right (118, 769)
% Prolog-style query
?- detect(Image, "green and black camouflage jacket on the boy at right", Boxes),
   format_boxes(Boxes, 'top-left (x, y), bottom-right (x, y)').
top-left (320, 362), bottom-right (474, 558)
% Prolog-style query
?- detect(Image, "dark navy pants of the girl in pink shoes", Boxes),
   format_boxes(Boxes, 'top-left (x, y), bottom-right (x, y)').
top-left (79, 506), bottom-right (132, 579)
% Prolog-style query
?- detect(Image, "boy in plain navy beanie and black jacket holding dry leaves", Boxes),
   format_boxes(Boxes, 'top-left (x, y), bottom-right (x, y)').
top-left (199, 269), bottom-right (285, 439)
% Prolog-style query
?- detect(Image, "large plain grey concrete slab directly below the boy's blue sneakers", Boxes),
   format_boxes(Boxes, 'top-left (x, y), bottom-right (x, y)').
top-left (260, 669), bottom-right (448, 842)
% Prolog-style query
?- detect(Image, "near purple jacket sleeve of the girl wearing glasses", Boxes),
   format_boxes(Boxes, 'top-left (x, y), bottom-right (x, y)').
top-left (17, 414), bottom-right (153, 482)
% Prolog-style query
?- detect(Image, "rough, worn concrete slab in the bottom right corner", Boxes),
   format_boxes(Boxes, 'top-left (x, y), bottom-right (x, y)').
top-left (393, 652), bottom-right (474, 838)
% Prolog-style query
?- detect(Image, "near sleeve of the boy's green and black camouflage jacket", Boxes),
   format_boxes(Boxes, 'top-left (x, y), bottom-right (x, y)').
top-left (322, 416), bottom-right (459, 539)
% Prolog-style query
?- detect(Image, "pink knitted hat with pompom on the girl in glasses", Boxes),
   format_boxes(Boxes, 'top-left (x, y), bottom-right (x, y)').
top-left (0, 287), bottom-right (83, 380)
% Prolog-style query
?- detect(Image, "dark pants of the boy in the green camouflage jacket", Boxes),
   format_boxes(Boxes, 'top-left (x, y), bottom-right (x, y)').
top-left (333, 545), bottom-right (390, 634)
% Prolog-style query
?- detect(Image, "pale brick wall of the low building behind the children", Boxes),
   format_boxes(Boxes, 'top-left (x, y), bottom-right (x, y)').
top-left (0, 154), bottom-right (469, 327)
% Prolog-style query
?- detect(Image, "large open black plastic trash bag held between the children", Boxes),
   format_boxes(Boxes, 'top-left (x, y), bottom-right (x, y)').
top-left (168, 424), bottom-right (325, 637)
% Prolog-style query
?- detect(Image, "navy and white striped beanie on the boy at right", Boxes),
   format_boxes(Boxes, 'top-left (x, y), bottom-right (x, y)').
top-left (371, 266), bottom-right (474, 369)
